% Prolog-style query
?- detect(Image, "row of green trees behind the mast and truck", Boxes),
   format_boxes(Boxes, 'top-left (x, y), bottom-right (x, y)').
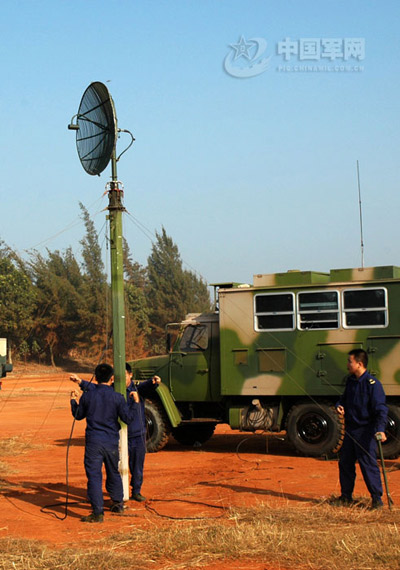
top-left (0, 204), bottom-right (210, 366)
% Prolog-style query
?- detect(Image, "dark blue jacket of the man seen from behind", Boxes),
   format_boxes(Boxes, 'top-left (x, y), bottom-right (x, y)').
top-left (71, 382), bottom-right (134, 445)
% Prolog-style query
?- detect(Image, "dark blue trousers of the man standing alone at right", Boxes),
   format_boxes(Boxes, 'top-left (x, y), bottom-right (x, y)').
top-left (339, 428), bottom-right (382, 499)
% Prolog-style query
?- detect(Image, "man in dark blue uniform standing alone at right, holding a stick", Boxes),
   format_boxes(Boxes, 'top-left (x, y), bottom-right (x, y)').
top-left (336, 348), bottom-right (388, 508)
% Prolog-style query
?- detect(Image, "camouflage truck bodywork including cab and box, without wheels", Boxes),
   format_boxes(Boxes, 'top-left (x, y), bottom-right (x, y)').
top-left (132, 266), bottom-right (400, 452)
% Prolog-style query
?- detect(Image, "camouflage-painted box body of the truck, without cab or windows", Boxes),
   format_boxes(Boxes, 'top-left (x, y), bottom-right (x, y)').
top-left (228, 266), bottom-right (400, 397)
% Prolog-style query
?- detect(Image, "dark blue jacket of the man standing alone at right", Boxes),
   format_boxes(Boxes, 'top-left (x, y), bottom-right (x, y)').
top-left (336, 372), bottom-right (388, 433)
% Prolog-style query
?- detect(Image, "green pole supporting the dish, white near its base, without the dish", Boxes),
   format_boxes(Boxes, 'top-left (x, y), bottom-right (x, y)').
top-left (108, 149), bottom-right (129, 501)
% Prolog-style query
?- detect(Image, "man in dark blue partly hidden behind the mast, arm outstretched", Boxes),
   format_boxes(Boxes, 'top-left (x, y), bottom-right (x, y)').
top-left (126, 363), bottom-right (161, 502)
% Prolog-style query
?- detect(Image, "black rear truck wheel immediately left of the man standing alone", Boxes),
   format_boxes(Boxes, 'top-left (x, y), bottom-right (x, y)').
top-left (286, 403), bottom-right (344, 457)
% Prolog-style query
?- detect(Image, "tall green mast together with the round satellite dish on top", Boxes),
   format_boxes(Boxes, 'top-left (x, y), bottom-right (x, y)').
top-left (68, 81), bottom-right (134, 500)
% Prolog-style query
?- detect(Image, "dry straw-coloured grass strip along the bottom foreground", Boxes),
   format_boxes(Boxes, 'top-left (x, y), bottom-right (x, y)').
top-left (0, 504), bottom-right (400, 570)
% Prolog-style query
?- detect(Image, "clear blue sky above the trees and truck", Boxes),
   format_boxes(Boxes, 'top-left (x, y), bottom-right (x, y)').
top-left (0, 0), bottom-right (400, 282)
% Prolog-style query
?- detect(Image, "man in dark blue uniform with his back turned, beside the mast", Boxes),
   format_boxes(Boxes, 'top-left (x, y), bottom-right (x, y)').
top-left (71, 364), bottom-right (135, 523)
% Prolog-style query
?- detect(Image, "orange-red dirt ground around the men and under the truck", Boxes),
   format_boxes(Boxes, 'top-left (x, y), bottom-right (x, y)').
top-left (0, 372), bottom-right (400, 570)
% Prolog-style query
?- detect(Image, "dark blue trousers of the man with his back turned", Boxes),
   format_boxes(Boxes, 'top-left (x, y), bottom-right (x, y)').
top-left (84, 442), bottom-right (124, 515)
